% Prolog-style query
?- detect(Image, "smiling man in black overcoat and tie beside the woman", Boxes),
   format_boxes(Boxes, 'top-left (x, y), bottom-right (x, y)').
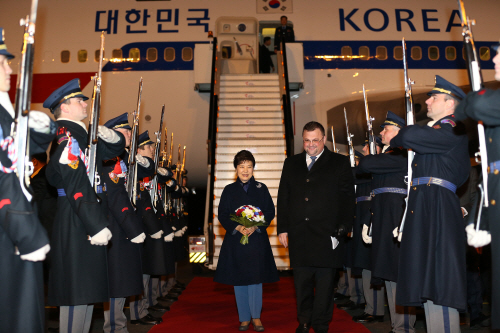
top-left (277, 121), bottom-right (354, 333)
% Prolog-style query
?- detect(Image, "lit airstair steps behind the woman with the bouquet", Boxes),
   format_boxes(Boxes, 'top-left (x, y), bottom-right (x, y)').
top-left (210, 74), bottom-right (290, 269)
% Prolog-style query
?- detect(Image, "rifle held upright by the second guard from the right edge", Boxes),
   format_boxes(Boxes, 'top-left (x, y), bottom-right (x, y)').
top-left (399, 38), bottom-right (415, 232)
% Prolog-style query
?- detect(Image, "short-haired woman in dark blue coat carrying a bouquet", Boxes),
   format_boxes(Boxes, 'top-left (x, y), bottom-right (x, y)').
top-left (214, 150), bottom-right (279, 332)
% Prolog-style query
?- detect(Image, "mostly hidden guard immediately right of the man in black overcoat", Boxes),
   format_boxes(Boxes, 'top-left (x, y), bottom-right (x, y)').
top-left (352, 136), bottom-right (385, 323)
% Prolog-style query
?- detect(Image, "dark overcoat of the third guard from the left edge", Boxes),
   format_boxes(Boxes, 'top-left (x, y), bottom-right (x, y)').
top-left (101, 154), bottom-right (144, 298)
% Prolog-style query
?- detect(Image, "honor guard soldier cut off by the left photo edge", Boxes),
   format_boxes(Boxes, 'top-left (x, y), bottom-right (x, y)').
top-left (0, 28), bottom-right (56, 333)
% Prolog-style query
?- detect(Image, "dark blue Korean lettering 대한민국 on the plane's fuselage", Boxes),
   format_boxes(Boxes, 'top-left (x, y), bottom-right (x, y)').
top-left (95, 8), bottom-right (210, 35)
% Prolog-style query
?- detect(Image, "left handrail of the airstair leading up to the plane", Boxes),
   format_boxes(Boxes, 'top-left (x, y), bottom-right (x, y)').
top-left (205, 37), bottom-right (220, 265)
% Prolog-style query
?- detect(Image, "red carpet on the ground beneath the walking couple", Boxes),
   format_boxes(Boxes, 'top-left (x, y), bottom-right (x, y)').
top-left (149, 277), bottom-right (370, 333)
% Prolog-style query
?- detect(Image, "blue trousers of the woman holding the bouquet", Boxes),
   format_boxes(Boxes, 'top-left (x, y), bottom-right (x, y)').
top-left (234, 283), bottom-right (262, 322)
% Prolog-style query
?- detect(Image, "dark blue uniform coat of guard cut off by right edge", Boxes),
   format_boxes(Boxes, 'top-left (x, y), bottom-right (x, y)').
top-left (455, 89), bottom-right (500, 329)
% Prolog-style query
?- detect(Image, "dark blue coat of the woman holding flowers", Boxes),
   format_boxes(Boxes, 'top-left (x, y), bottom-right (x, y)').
top-left (214, 177), bottom-right (279, 286)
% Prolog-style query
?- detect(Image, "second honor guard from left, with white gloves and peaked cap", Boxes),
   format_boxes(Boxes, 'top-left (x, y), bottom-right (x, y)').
top-left (43, 79), bottom-right (125, 332)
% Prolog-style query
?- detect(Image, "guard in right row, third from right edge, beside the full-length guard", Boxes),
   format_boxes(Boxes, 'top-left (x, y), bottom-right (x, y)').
top-left (357, 111), bottom-right (416, 332)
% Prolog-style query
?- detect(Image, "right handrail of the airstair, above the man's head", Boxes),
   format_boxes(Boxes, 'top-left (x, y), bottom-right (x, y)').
top-left (277, 40), bottom-right (294, 157)
